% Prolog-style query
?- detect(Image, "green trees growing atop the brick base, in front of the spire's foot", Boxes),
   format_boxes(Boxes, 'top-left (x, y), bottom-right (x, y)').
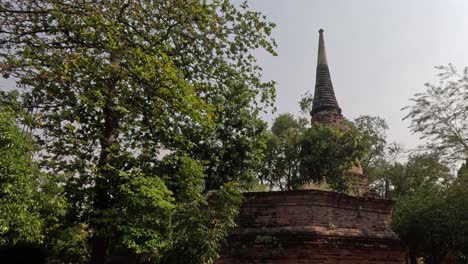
top-left (259, 114), bottom-right (370, 192)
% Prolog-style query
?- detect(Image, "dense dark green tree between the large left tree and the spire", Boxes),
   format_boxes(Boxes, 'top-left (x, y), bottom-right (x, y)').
top-left (189, 83), bottom-right (267, 193)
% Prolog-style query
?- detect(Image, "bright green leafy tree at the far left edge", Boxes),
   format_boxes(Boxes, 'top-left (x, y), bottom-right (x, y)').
top-left (0, 107), bottom-right (65, 254)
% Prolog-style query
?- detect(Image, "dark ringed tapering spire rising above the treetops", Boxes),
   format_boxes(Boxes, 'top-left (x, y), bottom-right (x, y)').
top-left (311, 29), bottom-right (341, 116)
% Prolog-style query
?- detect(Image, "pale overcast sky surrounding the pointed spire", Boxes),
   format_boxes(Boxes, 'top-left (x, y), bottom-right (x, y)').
top-left (250, 0), bottom-right (468, 148)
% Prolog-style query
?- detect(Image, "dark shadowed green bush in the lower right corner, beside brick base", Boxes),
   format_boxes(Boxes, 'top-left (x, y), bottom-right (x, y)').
top-left (392, 171), bottom-right (468, 263)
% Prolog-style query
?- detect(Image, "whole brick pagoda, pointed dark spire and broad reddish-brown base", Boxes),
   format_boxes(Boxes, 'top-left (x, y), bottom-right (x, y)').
top-left (216, 29), bottom-right (406, 264)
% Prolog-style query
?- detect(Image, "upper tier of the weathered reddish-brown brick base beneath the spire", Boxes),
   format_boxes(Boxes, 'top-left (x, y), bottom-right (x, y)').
top-left (238, 190), bottom-right (393, 232)
